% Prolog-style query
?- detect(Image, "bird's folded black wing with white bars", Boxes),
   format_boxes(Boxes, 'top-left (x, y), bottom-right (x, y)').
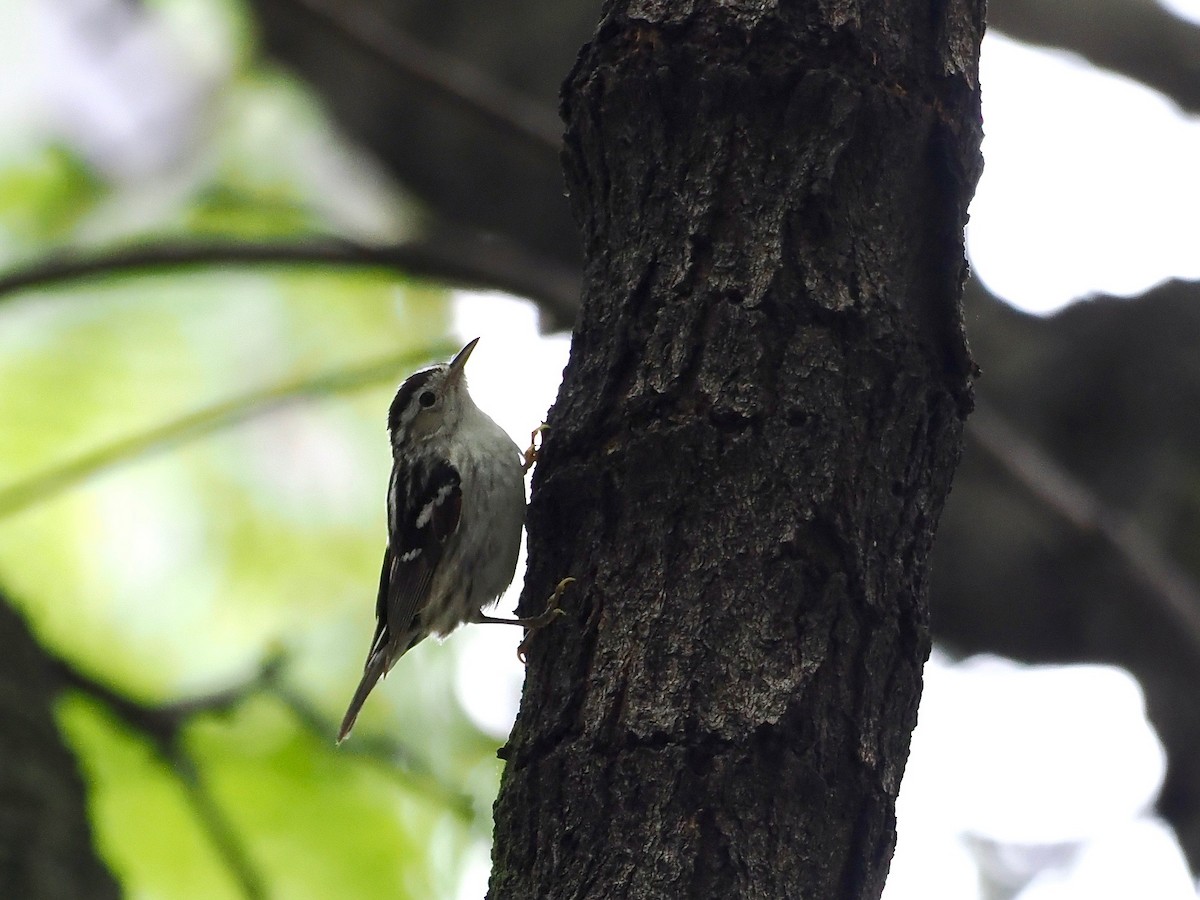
top-left (367, 460), bottom-right (462, 666)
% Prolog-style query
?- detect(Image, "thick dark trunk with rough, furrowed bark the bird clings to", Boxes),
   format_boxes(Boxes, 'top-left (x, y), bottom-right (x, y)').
top-left (490, 0), bottom-right (983, 900)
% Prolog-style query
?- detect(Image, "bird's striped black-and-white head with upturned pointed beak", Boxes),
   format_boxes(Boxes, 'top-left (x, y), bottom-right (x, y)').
top-left (388, 337), bottom-right (479, 448)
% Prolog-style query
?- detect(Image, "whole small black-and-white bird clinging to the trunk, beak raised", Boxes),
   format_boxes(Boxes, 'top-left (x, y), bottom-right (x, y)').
top-left (337, 337), bottom-right (570, 743)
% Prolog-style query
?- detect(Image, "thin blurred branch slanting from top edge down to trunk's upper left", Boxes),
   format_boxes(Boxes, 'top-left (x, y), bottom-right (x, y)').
top-left (287, 0), bottom-right (563, 160)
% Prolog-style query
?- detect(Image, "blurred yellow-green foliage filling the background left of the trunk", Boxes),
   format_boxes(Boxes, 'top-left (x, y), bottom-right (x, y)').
top-left (0, 0), bottom-right (499, 899)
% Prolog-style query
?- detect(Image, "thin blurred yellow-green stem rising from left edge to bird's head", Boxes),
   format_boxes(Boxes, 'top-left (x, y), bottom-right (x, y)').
top-left (0, 349), bottom-right (446, 517)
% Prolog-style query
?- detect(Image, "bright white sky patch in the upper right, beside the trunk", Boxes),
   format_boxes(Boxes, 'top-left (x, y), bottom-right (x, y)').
top-left (967, 33), bottom-right (1200, 312)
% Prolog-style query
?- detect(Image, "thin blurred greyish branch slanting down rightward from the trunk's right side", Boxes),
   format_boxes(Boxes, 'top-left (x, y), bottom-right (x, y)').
top-left (967, 398), bottom-right (1200, 649)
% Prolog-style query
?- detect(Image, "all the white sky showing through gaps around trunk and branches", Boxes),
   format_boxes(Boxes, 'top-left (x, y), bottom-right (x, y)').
top-left (0, 0), bottom-right (1200, 900)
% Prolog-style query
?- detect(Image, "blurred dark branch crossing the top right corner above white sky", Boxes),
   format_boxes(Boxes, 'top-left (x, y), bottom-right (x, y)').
top-left (988, 0), bottom-right (1200, 113)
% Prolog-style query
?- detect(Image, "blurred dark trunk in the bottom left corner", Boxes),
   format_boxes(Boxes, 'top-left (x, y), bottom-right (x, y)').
top-left (0, 594), bottom-right (119, 900)
